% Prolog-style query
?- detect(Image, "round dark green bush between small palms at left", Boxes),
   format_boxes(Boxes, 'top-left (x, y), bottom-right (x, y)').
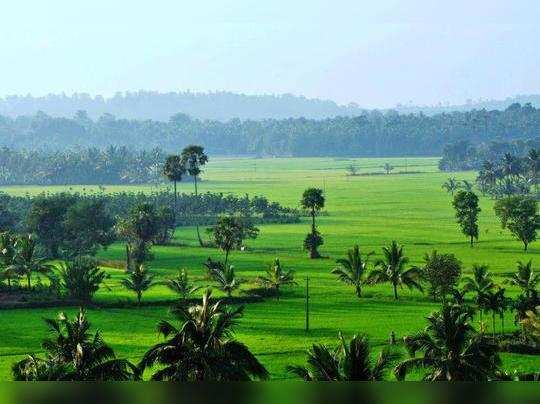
top-left (58, 257), bottom-right (107, 304)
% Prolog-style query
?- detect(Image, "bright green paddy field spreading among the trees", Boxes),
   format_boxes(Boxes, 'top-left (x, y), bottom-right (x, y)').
top-left (0, 158), bottom-right (540, 380)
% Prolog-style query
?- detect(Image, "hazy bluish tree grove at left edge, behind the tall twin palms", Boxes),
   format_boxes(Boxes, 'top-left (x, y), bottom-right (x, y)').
top-left (0, 146), bottom-right (165, 185)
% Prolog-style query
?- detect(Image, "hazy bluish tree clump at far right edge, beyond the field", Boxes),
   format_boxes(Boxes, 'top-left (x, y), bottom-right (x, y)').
top-left (439, 137), bottom-right (540, 171)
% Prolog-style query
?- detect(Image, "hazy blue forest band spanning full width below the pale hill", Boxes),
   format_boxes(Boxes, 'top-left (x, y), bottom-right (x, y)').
top-left (0, 104), bottom-right (540, 156)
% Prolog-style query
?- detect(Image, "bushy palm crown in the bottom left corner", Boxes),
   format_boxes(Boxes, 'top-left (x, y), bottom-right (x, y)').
top-left (12, 309), bottom-right (139, 381)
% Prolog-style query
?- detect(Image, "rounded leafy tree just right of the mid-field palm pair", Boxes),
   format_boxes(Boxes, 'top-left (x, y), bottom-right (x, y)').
top-left (422, 250), bottom-right (461, 301)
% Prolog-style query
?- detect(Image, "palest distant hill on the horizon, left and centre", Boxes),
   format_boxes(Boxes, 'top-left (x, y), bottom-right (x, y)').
top-left (0, 91), bottom-right (368, 121)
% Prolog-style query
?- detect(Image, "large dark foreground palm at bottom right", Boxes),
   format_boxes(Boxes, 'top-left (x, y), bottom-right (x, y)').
top-left (394, 303), bottom-right (501, 381)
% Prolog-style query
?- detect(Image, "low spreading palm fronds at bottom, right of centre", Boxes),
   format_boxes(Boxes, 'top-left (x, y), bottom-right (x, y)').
top-left (287, 332), bottom-right (399, 382)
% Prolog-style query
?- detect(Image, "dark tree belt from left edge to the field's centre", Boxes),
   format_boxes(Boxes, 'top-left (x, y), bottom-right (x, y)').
top-left (0, 191), bottom-right (301, 237)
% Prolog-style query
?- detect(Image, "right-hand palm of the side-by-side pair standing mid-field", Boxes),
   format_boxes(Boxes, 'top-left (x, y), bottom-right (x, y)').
top-left (369, 241), bottom-right (422, 300)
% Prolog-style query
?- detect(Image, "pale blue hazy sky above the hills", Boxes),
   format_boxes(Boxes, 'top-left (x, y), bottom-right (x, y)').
top-left (0, 0), bottom-right (540, 108)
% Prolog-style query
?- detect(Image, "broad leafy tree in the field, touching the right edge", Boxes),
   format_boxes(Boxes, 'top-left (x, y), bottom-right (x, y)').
top-left (494, 196), bottom-right (540, 251)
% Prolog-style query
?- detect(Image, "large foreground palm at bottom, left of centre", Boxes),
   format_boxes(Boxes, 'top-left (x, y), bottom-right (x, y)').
top-left (139, 290), bottom-right (268, 381)
